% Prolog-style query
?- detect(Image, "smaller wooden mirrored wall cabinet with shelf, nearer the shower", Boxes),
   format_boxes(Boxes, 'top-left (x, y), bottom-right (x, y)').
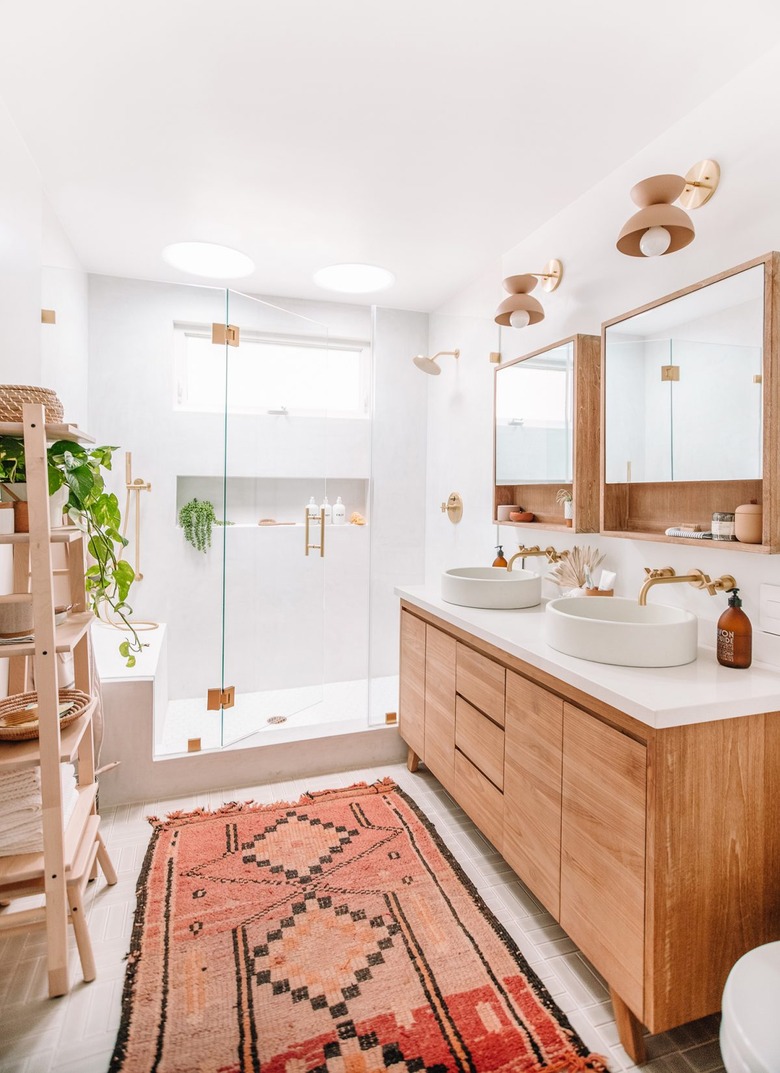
top-left (492, 335), bottom-right (601, 532)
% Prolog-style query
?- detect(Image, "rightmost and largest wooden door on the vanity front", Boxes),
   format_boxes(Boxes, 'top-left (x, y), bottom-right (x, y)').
top-left (560, 704), bottom-right (647, 1019)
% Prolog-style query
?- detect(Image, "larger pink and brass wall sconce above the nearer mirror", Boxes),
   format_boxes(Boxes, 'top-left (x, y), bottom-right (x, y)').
top-left (617, 160), bottom-right (720, 258)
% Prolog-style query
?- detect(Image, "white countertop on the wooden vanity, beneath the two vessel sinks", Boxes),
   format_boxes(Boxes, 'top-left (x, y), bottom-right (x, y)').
top-left (395, 586), bottom-right (780, 727)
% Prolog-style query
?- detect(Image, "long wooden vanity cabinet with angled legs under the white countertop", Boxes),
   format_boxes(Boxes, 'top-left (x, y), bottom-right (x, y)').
top-left (400, 604), bottom-right (780, 1062)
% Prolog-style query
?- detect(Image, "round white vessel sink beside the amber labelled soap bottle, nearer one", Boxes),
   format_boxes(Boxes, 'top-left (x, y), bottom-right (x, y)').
top-left (544, 597), bottom-right (698, 667)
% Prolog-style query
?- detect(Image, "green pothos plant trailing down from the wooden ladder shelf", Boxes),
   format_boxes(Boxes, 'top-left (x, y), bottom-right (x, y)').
top-left (0, 436), bottom-right (143, 667)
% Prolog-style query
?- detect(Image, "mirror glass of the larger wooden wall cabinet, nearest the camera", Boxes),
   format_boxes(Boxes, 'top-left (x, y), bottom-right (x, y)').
top-left (604, 264), bottom-right (764, 484)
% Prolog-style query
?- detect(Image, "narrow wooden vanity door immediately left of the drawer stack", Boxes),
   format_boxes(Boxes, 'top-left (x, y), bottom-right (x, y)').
top-left (424, 626), bottom-right (457, 789)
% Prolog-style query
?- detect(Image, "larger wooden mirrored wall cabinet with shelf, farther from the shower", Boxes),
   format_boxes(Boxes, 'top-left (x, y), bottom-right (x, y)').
top-left (601, 253), bottom-right (780, 555)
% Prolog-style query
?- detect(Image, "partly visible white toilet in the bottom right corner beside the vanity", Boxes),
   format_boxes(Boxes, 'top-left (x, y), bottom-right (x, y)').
top-left (720, 942), bottom-right (780, 1073)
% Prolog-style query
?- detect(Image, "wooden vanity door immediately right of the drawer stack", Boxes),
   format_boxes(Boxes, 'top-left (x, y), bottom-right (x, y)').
top-left (503, 671), bottom-right (563, 918)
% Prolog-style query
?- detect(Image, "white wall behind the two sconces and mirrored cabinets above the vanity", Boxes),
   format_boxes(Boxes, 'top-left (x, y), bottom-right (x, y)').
top-left (426, 41), bottom-right (780, 662)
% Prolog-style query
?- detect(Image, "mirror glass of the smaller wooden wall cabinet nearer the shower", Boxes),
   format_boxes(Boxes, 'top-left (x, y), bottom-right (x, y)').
top-left (496, 342), bottom-right (574, 485)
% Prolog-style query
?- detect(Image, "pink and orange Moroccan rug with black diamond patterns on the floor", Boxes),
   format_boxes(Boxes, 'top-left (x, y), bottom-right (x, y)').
top-left (111, 779), bottom-right (605, 1073)
